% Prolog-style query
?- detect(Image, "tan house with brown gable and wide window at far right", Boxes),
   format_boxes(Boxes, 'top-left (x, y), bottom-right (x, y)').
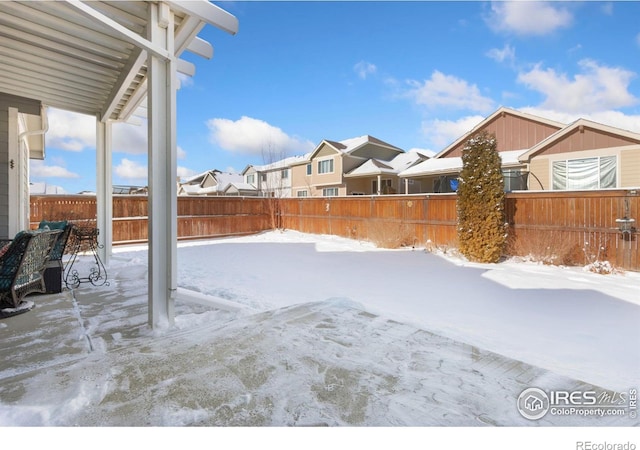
top-left (520, 119), bottom-right (640, 191)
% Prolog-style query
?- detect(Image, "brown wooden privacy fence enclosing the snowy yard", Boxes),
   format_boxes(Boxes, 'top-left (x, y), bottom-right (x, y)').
top-left (31, 190), bottom-right (640, 271)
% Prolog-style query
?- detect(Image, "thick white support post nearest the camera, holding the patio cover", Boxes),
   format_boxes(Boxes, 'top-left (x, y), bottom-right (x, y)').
top-left (147, 2), bottom-right (177, 328)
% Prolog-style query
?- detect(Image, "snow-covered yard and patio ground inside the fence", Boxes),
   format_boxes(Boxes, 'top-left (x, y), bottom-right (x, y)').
top-left (0, 231), bottom-right (640, 426)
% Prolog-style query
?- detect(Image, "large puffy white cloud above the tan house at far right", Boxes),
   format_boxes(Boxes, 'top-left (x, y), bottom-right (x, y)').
top-left (518, 59), bottom-right (639, 114)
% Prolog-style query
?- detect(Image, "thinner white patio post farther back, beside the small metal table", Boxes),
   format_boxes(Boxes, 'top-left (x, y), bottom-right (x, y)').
top-left (96, 120), bottom-right (113, 265)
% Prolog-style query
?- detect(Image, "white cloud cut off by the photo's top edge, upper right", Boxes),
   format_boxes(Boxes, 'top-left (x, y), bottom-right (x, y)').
top-left (485, 1), bottom-right (573, 36)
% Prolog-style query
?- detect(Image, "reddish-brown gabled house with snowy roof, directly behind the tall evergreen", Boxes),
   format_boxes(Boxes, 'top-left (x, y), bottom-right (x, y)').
top-left (400, 107), bottom-right (565, 193)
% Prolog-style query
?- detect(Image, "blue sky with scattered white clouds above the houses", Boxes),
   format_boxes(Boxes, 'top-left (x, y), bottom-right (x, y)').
top-left (31, 1), bottom-right (640, 193)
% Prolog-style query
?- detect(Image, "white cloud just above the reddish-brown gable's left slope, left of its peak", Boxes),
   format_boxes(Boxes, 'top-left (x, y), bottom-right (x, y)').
top-left (405, 70), bottom-right (494, 112)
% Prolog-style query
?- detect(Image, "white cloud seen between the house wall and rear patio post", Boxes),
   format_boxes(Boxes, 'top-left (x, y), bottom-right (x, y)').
top-left (45, 108), bottom-right (96, 152)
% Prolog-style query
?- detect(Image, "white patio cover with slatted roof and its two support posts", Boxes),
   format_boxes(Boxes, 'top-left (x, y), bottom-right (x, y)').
top-left (0, 0), bottom-right (238, 327)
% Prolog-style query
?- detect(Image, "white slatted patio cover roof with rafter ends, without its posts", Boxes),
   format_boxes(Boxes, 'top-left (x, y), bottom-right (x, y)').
top-left (0, 0), bottom-right (238, 121)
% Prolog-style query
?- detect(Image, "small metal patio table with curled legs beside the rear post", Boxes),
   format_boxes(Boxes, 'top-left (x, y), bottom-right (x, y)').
top-left (64, 226), bottom-right (109, 288)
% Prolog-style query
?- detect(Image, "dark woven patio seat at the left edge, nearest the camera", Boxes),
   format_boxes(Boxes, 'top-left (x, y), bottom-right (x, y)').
top-left (0, 230), bottom-right (62, 318)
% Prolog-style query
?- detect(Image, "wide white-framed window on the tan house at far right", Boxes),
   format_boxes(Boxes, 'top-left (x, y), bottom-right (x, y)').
top-left (552, 156), bottom-right (618, 191)
